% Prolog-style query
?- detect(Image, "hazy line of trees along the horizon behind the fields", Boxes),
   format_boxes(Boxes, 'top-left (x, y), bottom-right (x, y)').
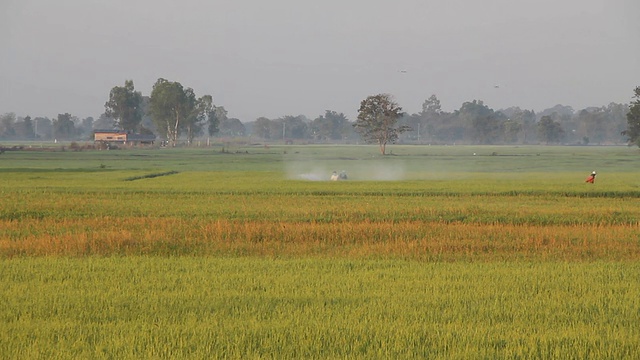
top-left (0, 78), bottom-right (640, 148)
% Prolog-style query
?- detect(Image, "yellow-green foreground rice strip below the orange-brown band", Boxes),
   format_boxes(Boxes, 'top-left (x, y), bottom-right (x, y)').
top-left (0, 256), bottom-right (640, 359)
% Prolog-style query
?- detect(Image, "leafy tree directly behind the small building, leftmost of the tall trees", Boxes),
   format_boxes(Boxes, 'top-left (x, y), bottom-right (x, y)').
top-left (104, 80), bottom-right (142, 132)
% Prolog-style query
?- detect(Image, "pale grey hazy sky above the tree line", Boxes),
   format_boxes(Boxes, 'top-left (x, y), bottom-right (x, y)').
top-left (0, 0), bottom-right (640, 122)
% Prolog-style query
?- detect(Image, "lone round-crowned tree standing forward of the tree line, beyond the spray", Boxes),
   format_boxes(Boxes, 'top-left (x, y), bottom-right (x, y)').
top-left (353, 94), bottom-right (411, 155)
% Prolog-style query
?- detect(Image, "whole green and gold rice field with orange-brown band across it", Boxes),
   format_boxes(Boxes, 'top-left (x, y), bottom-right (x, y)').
top-left (0, 146), bottom-right (640, 359)
